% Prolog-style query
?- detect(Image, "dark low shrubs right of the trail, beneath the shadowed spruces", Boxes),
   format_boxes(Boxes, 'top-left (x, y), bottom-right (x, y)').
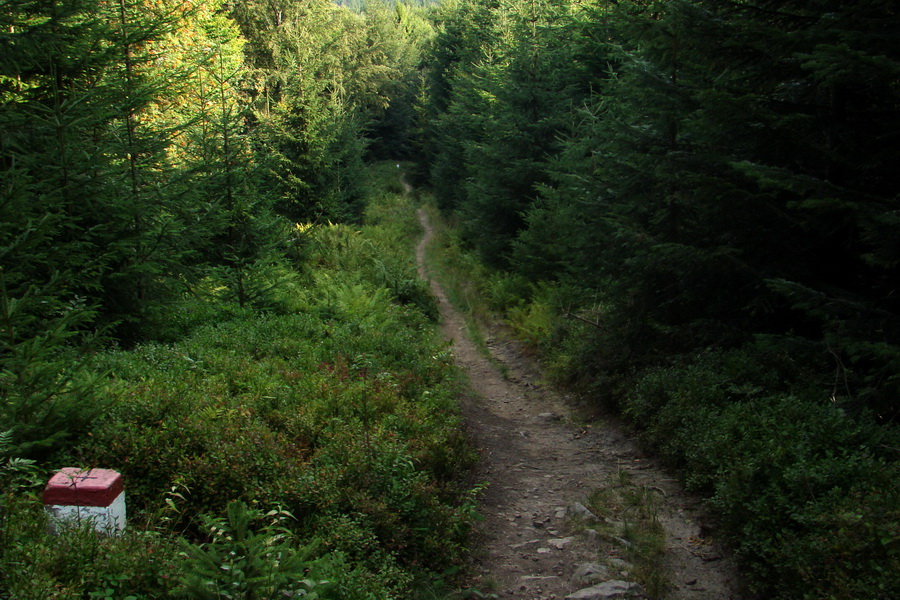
top-left (625, 350), bottom-right (900, 599)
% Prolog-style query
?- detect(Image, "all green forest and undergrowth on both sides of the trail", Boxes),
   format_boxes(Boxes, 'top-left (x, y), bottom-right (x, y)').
top-left (0, 0), bottom-right (900, 599)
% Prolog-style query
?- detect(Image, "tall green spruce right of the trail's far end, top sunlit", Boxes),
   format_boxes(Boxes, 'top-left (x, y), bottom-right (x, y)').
top-left (427, 0), bottom-right (590, 264)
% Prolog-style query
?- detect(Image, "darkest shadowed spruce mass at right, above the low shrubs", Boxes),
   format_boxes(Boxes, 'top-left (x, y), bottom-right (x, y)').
top-left (517, 1), bottom-right (898, 412)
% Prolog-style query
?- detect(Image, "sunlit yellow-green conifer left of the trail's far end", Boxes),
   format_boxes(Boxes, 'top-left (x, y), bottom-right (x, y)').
top-left (233, 0), bottom-right (393, 220)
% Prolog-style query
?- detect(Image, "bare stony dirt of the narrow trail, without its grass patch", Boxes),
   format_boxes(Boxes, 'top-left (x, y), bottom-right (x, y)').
top-left (414, 206), bottom-right (739, 600)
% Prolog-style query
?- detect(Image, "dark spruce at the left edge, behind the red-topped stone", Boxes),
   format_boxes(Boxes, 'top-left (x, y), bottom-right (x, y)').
top-left (0, 1), bottom-right (142, 454)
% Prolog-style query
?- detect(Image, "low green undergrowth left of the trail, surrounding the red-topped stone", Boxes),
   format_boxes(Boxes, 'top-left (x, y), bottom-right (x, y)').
top-left (0, 165), bottom-right (475, 599)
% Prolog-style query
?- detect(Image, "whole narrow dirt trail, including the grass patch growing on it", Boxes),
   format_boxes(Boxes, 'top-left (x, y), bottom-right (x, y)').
top-left (416, 210), bottom-right (739, 600)
